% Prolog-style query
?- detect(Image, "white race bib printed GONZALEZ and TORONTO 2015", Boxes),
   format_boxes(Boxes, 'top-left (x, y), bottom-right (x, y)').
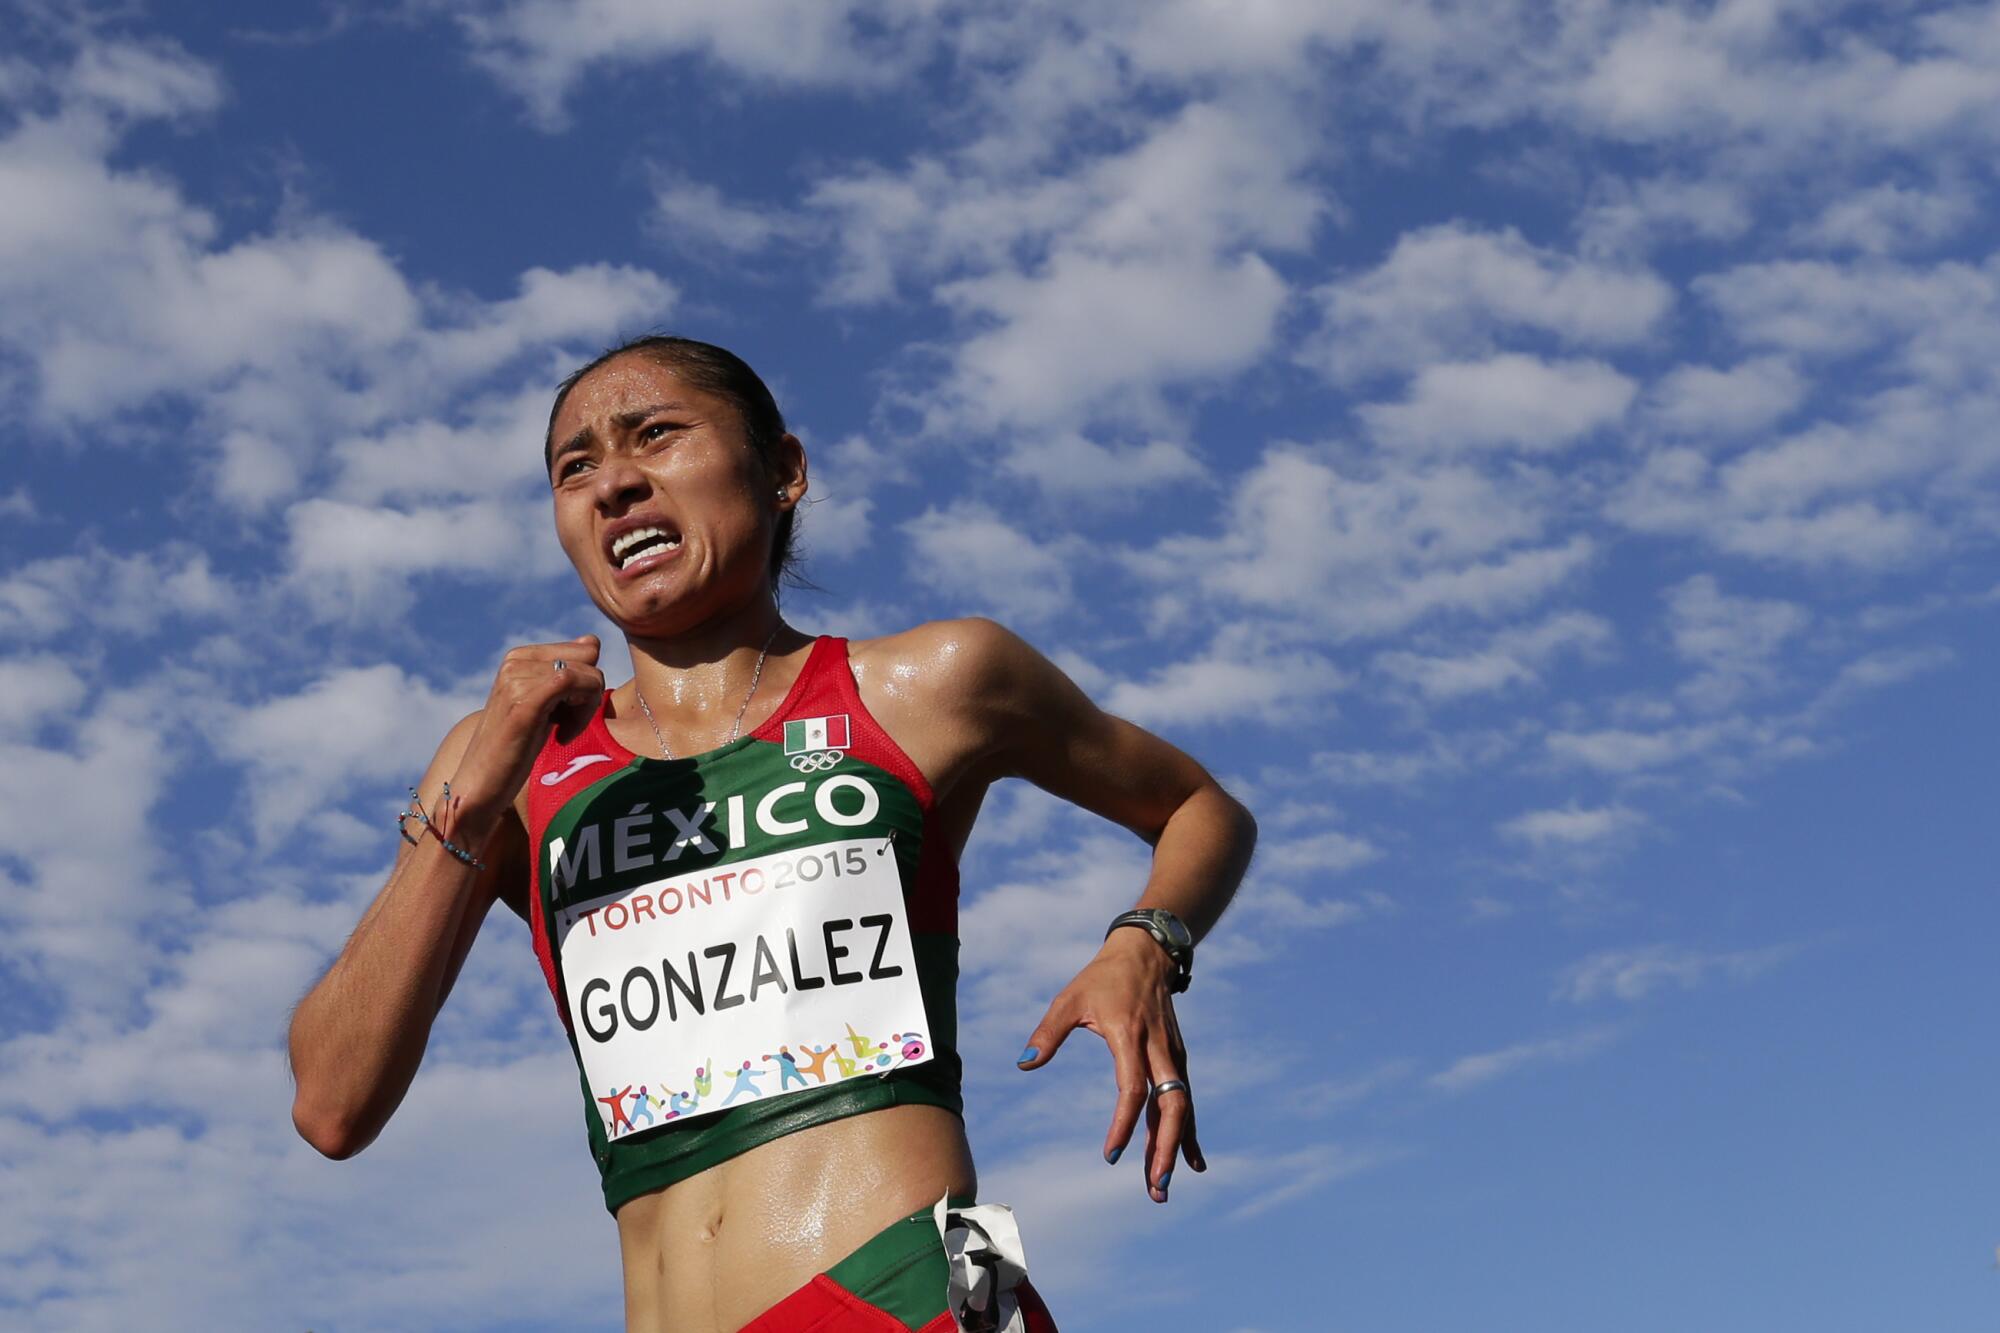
top-left (556, 839), bottom-right (930, 1139)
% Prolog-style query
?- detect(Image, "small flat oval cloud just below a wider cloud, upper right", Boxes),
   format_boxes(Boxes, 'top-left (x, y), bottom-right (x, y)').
top-left (1358, 352), bottom-right (1636, 450)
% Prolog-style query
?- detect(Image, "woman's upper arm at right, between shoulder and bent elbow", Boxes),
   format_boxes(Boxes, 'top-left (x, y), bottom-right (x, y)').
top-left (954, 616), bottom-right (1216, 843)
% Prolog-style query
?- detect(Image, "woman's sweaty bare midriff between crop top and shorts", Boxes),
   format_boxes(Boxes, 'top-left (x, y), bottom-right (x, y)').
top-left (618, 1105), bottom-right (976, 1333)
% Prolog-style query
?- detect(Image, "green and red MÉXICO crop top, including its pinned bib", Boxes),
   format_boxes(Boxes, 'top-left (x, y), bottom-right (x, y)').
top-left (528, 634), bottom-right (964, 1215)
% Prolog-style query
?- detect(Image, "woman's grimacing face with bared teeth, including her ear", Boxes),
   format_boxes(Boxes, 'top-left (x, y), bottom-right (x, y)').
top-left (548, 354), bottom-right (806, 634)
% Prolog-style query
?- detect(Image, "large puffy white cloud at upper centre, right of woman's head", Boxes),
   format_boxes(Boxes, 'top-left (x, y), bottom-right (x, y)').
top-left (810, 104), bottom-right (1326, 434)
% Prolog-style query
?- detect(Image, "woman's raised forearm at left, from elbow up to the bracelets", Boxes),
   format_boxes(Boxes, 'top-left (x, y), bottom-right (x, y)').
top-left (290, 837), bottom-right (484, 1157)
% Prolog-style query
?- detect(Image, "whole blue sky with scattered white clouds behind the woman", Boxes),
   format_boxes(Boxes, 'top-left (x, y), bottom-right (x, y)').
top-left (0, 0), bottom-right (2000, 1333)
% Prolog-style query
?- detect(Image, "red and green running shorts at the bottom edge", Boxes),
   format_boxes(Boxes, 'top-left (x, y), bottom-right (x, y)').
top-left (742, 1195), bottom-right (1056, 1333)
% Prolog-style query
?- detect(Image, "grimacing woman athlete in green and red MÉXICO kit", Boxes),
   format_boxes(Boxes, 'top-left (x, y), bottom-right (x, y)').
top-left (290, 336), bottom-right (1254, 1333)
